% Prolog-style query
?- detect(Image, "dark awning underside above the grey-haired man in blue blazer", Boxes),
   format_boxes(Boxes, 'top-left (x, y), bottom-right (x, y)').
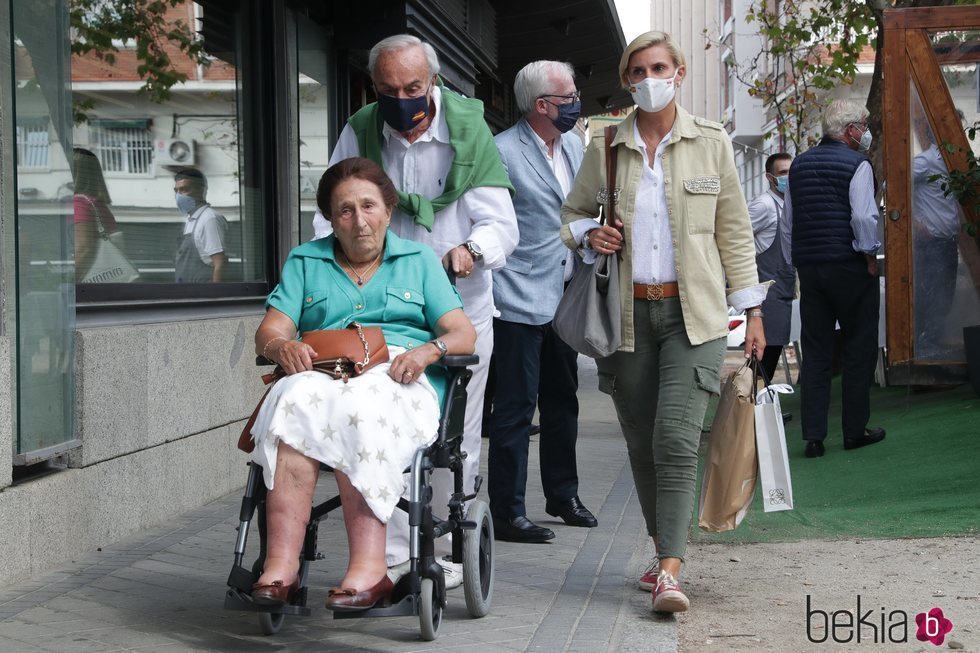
top-left (491, 0), bottom-right (633, 116)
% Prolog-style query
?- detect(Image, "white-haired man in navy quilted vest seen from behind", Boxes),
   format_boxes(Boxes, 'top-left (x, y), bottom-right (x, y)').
top-left (784, 100), bottom-right (885, 458)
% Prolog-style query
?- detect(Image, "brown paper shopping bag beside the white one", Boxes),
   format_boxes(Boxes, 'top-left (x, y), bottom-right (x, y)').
top-left (698, 364), bottom-right (757, 532)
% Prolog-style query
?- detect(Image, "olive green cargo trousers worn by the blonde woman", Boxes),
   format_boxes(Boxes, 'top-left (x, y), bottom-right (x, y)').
top-left (596, 297), bottom-right (725, 559)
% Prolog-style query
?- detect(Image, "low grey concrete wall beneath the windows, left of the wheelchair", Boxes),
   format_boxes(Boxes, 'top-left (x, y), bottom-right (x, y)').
top-left (0, 315), bottom-right (263, 582)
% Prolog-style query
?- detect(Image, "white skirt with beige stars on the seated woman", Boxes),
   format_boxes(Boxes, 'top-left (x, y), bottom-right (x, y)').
top-left (252, 345), bottom-right (439, 523)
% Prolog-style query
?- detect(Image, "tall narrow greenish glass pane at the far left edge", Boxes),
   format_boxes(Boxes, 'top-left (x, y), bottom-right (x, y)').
top-left (9, 2), bottom-right (78, 464)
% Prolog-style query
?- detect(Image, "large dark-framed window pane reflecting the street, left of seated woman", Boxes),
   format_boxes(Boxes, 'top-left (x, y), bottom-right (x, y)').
top-left (71, 0), bottom-right (271, 290)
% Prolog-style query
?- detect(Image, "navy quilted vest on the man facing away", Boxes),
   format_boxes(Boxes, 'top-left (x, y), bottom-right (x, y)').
top-left (789, 137), bottom-right (868, 266)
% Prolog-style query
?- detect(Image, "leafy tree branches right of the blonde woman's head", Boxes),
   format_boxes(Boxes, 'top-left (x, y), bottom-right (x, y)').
top-left (736, 0), bottom-right (877, 151)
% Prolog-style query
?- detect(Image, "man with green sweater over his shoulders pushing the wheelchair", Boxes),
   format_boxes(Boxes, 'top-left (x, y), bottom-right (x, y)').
top-left (313, 34), bottom-right (518, 588)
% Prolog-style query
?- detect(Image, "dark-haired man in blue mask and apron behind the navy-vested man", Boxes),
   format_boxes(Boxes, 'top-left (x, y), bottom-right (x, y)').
top-left (749, 152), bottom-right (796, 380)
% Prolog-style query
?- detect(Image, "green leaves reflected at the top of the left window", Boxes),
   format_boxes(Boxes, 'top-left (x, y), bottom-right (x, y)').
top-left (69, 0), bottom-right (210, 109)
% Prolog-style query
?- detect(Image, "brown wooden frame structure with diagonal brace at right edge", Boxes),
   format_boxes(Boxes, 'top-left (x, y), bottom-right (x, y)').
top-left (882, 6), bottom-right (980, 385)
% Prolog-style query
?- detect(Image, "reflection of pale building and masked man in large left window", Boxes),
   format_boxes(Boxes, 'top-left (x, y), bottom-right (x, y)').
top-left (60, 0), bottom-right (265, 283)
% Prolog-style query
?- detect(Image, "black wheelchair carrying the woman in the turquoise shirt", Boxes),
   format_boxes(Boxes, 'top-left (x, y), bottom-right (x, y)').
top-left (224, 356), bottom-right (494, 641)
